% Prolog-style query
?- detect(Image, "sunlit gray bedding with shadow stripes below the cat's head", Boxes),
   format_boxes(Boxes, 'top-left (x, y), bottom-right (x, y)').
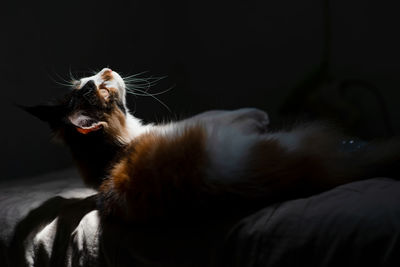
top-left (0, 170), bottom-right (99, 266)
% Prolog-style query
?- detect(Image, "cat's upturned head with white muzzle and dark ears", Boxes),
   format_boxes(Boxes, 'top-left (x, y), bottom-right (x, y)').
top-left (24, 68), bottom-right (129, 146)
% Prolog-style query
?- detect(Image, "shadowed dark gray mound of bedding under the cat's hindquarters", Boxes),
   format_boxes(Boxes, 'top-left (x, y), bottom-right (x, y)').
top-left (221, 178), bottom-right (400, 267)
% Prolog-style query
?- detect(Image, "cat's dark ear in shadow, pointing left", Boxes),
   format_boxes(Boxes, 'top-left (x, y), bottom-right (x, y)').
top-left (17, 104), bottom-right (63, 123)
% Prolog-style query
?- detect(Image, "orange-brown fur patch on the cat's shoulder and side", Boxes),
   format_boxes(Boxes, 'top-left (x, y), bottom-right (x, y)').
top-left (100, 127), bottom-right (207, 221)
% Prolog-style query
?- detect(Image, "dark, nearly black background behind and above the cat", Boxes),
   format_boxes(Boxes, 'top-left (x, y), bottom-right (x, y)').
top-left (0, 0), bottom-right (400, 180)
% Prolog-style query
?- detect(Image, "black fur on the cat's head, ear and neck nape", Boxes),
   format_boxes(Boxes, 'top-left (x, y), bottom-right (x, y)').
top-left (19, 81), bottom-right (126, 187)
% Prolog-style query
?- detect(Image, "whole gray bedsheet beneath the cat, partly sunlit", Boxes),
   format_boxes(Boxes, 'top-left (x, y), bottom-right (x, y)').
top-left (0, 170), bottom-right (400, 266)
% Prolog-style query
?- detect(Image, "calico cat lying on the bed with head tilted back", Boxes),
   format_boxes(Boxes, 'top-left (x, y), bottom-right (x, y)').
top-left (24, 68), bottom-right (400, 222)
